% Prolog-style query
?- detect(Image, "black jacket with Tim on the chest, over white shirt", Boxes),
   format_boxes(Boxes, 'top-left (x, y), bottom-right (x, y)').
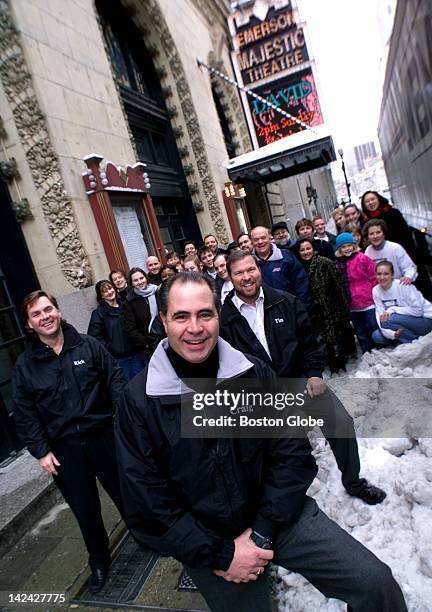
top-left (220, 285), bottom-right (325, 378)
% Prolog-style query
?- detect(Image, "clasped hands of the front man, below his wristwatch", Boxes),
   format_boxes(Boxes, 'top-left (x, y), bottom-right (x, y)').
top-left (214, 529), bottom-right (274, 583)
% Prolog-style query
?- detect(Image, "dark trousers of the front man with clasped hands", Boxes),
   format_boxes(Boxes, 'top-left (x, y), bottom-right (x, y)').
top-left (187, 498), bottom-right (407, 612)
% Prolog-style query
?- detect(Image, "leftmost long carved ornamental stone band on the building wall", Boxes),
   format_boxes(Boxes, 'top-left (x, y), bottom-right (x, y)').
top-left (0, 0), bottom-right (92, 289)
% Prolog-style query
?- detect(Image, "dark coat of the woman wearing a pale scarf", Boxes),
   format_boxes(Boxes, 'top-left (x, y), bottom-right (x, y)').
top-left (124, 289), bottom-right (156, 359)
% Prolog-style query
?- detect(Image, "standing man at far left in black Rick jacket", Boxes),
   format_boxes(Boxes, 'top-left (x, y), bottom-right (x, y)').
top-left (13, 291), bottom-right (124, 593)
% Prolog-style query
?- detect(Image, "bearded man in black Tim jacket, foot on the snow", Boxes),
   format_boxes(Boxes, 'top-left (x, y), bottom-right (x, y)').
top-left (220, 252), bottom-right (386, 505)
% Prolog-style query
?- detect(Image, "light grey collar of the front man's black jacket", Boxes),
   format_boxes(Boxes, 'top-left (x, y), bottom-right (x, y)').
top-left (146, 338), bottom-right (253, 397)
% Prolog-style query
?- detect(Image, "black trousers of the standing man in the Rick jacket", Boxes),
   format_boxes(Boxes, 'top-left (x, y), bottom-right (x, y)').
top-left (51, 428), bottom-right (123, 569)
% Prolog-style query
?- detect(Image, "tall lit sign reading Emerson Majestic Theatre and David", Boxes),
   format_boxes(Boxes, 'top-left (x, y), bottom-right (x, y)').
top-left (230, 0), bottom-right (324, 148)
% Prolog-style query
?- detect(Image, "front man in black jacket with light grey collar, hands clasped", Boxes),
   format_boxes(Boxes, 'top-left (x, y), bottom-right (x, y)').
top-left (116, 272), bottom-right (406, 612)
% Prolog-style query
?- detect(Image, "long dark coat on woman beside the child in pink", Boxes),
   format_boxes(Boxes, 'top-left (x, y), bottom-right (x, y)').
top-left (305, 253), bottom-right (350, 344)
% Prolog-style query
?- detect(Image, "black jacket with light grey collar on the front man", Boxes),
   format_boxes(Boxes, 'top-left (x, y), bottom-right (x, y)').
top-left (116, 340), bottom-right (316, 570)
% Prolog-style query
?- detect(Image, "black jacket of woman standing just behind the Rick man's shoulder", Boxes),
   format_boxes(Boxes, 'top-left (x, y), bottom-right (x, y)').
top-left (87, 302), bottom-right (134, 359)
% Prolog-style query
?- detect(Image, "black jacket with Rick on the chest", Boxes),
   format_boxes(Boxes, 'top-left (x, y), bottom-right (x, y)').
top-left (12, 323), bottom-right (124, 459)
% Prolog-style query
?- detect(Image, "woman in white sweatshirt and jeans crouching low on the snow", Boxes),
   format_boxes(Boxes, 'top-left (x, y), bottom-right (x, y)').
top-left (372, 261), bottom-right (432, 344)
